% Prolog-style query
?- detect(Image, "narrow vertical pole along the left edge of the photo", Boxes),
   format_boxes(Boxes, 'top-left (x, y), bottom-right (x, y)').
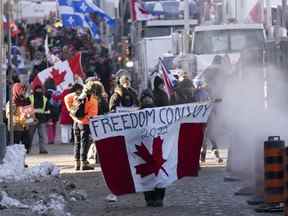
top-left (0, 0), bottom-right (6, 164)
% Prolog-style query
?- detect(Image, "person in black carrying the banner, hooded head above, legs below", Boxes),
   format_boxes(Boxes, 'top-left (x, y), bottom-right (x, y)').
top-left (140, 89), bottom-right (165, 207)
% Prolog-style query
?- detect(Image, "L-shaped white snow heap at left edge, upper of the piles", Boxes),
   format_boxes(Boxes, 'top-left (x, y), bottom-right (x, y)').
top-left (0, 144), bottom-right (60, 182)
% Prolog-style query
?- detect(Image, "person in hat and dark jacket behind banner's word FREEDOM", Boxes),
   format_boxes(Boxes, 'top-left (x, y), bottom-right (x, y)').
top-left (109, 75), bottom-right (139, 112)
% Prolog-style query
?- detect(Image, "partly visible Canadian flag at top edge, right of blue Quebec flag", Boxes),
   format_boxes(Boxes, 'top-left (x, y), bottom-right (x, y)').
top-left (131, 0), bottom-right (157, 21)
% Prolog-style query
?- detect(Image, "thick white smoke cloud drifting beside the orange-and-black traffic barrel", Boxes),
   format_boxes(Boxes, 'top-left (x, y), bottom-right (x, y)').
top-left (217, 62), bottom-right (288, 181)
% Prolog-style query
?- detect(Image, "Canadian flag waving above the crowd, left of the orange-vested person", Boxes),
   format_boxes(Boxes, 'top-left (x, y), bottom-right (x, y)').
top-left (31, 52), bottom-right (84, 92)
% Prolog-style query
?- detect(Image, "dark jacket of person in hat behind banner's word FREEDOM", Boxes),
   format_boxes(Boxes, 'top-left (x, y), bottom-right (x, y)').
top-left (109, 86), bottom-right (139, 111)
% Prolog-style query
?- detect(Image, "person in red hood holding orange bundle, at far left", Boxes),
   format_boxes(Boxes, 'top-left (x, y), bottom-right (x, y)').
top-left (6, 83), bottom-right (36, 153)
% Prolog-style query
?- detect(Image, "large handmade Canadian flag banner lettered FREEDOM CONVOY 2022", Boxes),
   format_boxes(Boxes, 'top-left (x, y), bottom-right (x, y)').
top-left (90, 102), bottom-right (212, 195)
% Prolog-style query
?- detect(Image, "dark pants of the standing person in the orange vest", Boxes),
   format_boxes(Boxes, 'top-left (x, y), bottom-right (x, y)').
top-left (73, 123), bottom-right (90, 161)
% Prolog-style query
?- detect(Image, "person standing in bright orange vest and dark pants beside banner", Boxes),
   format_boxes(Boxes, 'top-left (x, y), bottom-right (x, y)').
top-left (65, 81), bottom-right (98, 171)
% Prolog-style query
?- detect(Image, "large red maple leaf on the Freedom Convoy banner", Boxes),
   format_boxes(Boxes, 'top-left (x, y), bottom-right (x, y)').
top-left (134, 137), bottom-right (168, 178)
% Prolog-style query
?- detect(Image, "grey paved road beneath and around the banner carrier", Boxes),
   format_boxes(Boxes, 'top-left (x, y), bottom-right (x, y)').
top-left (22, 145), bottom-right (279, 216)
